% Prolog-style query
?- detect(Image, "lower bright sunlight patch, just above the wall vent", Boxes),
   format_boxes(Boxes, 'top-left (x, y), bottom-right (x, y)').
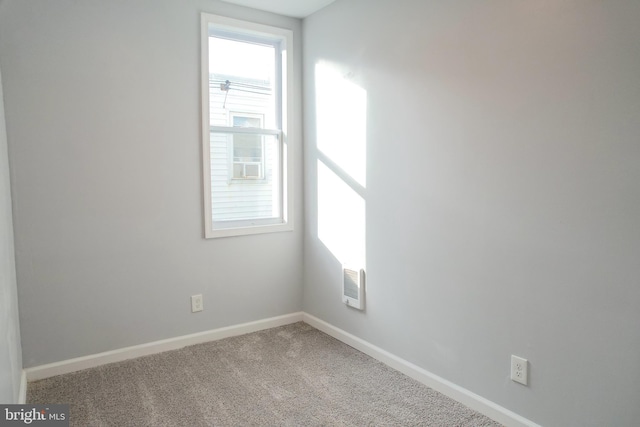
top-left (318, 160), bottom-right (366, 267)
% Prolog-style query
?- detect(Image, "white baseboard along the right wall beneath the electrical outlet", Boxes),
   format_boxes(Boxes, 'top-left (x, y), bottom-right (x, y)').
top-left (302, 313), bottom-right (540, 427)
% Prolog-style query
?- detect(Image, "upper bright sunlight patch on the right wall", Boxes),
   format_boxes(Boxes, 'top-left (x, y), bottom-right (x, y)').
top-left (315, 62), bottom-right (367, 187)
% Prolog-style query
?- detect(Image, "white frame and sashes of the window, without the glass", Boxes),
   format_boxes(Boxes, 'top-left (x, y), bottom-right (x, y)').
top-left (200, 12), bottom-right (293, 239)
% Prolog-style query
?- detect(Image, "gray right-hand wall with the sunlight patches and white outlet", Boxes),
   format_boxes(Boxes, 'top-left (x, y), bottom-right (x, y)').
top-left (303, 0), bottom-right (640, 426)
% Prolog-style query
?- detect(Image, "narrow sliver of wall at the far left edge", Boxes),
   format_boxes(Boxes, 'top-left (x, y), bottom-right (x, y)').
top-left (0, 61), bottom-right (22, 403)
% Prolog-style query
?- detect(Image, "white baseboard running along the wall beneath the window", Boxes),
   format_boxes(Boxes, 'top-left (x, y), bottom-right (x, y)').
top-left (24, 312), bottom-right (303, 382)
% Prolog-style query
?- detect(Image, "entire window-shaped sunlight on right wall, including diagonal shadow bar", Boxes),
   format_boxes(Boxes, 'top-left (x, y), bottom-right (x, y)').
top-left (315, 62), bottom-right (367, 268)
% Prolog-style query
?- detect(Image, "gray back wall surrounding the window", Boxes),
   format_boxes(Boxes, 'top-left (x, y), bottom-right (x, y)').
top-left (0, 0), bottom-right (303, 367)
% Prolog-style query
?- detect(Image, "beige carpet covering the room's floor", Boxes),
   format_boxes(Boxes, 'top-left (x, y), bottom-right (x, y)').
top-left (28, 322), bottom-right (499, 427)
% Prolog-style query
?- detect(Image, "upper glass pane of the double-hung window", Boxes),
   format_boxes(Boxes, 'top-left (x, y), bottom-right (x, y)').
top-left (209, 37), bottom-right (278, 129)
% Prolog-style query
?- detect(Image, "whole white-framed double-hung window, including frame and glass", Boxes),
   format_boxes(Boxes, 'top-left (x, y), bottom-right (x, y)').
top-left (201, 13), bottom-right (293, 238)
